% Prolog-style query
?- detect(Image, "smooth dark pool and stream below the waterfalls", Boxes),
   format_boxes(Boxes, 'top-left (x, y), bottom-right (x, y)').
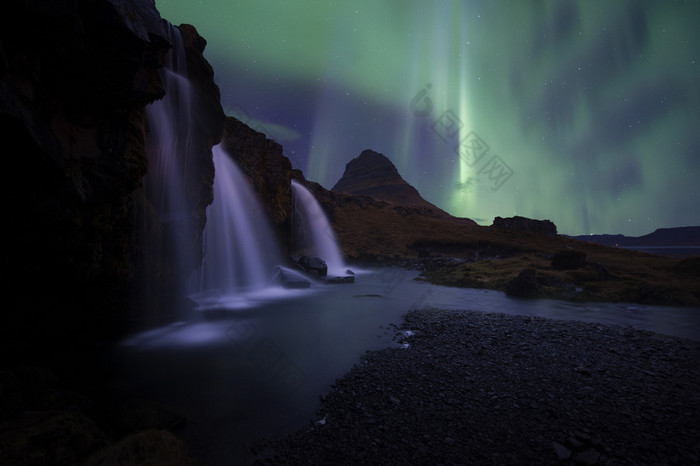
top-left (115, 268), bottom-right (700, 464)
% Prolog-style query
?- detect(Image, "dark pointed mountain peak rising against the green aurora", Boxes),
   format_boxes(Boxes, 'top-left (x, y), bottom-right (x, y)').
top-left (331, 149), bottom-right (460, 216)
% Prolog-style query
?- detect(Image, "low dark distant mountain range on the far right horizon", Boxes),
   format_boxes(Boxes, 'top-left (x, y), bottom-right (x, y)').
top-left (571, 226), bottom-right (700, 247)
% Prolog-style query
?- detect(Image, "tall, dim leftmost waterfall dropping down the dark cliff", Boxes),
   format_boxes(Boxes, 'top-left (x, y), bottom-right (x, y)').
top-left (136, 22), bottom-right (199, 320)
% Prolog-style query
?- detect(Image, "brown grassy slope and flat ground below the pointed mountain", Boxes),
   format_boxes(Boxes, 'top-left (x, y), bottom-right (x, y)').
top-left (333, 203), bottom-right (700, 306)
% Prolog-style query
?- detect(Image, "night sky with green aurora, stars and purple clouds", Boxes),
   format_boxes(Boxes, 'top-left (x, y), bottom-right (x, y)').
top-left (156, 0), bottom-right (700, 236)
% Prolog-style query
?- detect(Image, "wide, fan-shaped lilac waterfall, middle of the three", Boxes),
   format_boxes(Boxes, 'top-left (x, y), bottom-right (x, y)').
top-left (189, 145), bottom-right (282, 293)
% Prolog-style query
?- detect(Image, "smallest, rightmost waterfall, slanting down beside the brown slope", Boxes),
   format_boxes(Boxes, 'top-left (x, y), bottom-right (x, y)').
top-left (292, 180), bottom-right (346, 275)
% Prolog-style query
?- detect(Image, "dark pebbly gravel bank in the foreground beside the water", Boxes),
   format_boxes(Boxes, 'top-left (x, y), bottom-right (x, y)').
top-left (252, 310), bottom-right (700, 465)
